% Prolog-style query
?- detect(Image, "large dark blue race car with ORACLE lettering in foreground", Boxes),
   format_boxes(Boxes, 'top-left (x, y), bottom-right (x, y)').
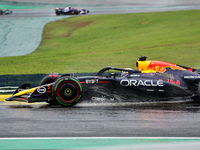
top-left (6, 57), bottom-right (200, 106)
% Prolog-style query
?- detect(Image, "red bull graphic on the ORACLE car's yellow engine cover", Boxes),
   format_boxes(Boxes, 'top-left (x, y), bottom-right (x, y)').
top-left (146, 61), bottom-right (185, 73)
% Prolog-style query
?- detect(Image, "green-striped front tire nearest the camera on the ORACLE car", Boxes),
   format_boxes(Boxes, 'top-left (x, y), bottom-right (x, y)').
top-left (52, 77), bottom-right (82, 106)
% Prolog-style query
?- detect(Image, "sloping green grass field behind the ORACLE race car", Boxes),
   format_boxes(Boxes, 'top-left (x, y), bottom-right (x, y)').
top-left (0, 10), bottom-right (200, 74)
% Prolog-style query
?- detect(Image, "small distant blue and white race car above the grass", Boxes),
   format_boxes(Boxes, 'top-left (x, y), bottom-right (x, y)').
top-left (55, 7), bottom-right (90, 15)
